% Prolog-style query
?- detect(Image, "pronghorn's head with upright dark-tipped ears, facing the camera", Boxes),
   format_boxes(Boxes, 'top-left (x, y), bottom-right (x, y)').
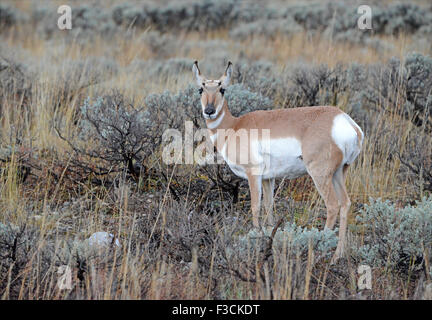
top-left (192, 61), bottom-right (232, 120)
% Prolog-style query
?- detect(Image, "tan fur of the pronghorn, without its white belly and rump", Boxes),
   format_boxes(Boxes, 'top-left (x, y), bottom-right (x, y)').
top-left (194, 64), bottom-right (363, 262)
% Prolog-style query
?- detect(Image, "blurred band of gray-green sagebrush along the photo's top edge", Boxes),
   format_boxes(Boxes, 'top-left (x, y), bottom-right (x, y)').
top-left (5, 0), bottom-right (432, 39)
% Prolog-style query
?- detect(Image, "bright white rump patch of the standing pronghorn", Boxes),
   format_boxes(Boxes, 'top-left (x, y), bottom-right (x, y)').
top-left (331, 113), bottom-right (363, 164)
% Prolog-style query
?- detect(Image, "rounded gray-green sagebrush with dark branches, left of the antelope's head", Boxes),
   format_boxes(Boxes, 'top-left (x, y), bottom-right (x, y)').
top-left (80, 92), bottom-right (169, 174)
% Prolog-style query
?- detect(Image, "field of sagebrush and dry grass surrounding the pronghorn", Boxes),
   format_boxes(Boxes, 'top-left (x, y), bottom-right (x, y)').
top-left (0, 0), bottom-right (432, 299)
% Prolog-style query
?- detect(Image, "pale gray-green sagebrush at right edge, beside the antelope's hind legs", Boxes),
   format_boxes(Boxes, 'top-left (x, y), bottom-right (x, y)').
top-left (353, 197), bottom-right (432, 272)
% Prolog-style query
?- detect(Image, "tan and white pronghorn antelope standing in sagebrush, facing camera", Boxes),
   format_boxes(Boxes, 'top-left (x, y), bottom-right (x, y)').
top-left (192, 61), bottom-right (363, 262)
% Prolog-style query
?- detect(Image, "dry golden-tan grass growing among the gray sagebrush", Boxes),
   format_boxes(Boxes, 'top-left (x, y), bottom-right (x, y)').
top-left (0, 1), bottom-right (432, 299)
